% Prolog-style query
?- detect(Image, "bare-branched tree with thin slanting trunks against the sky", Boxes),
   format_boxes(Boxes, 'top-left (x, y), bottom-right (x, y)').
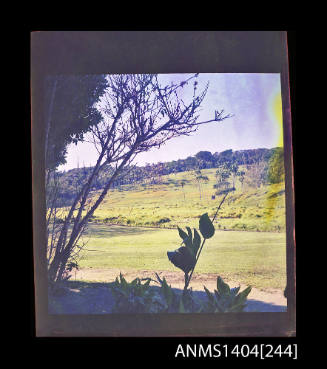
top-left (49, 74), bottom-right (229, 281)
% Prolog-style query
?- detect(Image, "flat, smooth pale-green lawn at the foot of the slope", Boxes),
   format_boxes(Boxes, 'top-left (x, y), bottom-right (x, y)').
top-left (79, 224), bottom-right (286, 289)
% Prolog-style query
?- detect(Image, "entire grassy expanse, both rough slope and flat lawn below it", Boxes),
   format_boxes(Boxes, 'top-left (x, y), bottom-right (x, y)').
top-left (56, 169), bottom-right (286, 289)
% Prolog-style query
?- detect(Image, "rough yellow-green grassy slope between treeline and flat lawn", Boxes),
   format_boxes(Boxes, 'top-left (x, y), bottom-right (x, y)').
top-left (70, 169), bottom-right (285, 232)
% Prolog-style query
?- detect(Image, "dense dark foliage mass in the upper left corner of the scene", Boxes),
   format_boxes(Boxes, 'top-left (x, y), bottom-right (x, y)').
top-left (45, 75), bottom-right (108, 169)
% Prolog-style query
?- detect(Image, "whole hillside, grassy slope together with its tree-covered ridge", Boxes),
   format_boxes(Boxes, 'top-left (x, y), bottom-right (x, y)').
top-left (52, 148), bottom-right (285, 232)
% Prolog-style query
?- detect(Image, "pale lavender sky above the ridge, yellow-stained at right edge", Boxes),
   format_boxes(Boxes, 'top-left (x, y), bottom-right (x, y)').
top-left (58, 73), bottom-right (283, 171)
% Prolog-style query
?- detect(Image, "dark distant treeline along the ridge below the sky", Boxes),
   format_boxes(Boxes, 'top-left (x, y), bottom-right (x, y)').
top-left (51, 147), bottom-right (283, 206)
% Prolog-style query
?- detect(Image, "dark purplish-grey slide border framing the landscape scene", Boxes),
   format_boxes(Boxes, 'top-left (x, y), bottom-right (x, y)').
top-left (31, 31), bottom-right (296, 337)
